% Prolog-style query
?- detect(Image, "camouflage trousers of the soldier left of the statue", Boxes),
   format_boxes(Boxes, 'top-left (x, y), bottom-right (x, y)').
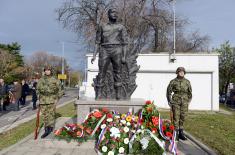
top-left (40, 104), bottom-right (55, 126)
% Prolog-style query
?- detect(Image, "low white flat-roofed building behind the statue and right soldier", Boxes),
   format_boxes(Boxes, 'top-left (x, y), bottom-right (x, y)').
top-left (85, 53), bottom-right (219, 111)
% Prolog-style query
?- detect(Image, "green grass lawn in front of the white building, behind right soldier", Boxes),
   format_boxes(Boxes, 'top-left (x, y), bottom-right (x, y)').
top-left (160, 105), bottom-right (235, 155)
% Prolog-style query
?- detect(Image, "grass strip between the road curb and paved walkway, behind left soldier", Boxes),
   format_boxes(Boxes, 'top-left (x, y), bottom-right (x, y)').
top-left (0, 102), bottom-right (76, 150)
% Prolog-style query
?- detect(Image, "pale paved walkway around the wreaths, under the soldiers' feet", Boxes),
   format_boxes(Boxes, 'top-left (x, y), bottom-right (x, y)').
top-left (0, 117), bottom-right (207, 155)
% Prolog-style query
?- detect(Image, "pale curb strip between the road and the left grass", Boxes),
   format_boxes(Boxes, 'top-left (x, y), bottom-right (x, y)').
top-left (0, 99), bottom-right (76, 134)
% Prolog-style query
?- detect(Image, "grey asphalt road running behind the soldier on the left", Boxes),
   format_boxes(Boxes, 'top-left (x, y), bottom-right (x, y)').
top-left (0, 89), bottom-right (78, 128)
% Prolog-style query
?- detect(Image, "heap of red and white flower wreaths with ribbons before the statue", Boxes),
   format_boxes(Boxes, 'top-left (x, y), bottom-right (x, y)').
top-left (54, 101), bottom-right (177, 155)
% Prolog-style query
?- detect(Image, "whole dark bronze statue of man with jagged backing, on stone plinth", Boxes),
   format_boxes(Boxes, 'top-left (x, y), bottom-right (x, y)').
top-left (91, 8), bottom-right (139, 100)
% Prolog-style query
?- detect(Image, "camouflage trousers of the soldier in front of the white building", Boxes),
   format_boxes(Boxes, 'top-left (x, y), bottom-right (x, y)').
top-left (172, 103), bottom-right (188, 129)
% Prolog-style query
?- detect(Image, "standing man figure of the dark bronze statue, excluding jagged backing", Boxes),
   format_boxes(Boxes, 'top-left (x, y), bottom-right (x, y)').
top-left (91, 8), bottom-right (128, 100)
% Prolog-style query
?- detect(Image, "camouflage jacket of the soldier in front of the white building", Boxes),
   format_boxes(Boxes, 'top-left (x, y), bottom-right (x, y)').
top-left (166, 78), bottom-right (192, 104)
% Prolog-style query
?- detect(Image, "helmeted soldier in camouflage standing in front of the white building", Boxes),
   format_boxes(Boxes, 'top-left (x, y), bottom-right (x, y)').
top-left (167, 67), bottom-right (192, 140)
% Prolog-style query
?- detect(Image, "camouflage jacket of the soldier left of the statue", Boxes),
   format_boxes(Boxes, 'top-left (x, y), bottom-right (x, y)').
top-left (37, 76), bottom-right (61, 104)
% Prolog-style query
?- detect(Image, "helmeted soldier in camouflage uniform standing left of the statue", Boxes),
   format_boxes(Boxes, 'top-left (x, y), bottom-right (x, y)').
top-left (37, 66), bottom-right (61, 138)
